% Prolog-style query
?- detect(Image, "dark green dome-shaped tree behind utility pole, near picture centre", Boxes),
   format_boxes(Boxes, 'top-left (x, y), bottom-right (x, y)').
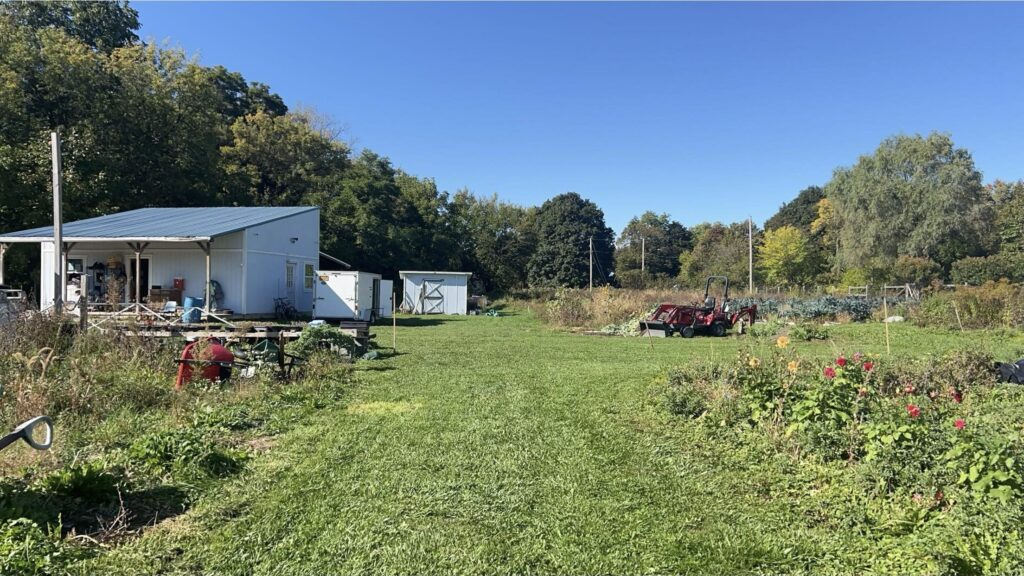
top-left (528, 192), bottom-right (614, 288)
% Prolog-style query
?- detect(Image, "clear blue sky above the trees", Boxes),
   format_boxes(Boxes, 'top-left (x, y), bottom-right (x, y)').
top-left (134, 2), bottom-right (1024, 234)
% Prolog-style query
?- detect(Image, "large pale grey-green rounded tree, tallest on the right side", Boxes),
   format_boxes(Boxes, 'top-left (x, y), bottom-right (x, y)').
top-left (825, 133), bottom-right (991, 269)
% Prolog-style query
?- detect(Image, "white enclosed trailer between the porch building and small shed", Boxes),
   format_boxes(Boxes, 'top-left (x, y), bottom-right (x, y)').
top-left (313, 270), bottom-right (394, 322)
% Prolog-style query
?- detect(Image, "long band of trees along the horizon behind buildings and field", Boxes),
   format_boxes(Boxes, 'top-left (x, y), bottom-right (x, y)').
top-left (0, 1), bottom-right (1024, 292)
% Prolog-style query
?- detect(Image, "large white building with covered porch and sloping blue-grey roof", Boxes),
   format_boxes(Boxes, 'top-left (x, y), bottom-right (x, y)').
top-left (0, 206), bottom-right (321, 316)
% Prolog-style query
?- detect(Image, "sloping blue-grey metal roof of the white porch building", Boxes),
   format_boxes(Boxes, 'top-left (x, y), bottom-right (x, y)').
top-left (0, 206), bottom-right (317, 243)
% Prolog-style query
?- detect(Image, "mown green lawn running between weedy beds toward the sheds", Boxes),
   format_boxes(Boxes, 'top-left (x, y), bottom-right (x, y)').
top-left (90, 315), bottom-right (1024, 575)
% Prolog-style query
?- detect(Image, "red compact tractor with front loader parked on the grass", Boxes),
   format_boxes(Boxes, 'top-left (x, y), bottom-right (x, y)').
top-left (640, 276), bottom-right (758, 338)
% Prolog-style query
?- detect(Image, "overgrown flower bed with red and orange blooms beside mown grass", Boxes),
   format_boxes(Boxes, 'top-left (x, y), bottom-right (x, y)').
top-left (659, 337), bottom-right (1024, 574)
